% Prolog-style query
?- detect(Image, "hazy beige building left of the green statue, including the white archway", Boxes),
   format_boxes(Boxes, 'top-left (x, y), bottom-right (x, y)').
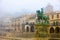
top-left (11, 14), bottom-right (36, 32)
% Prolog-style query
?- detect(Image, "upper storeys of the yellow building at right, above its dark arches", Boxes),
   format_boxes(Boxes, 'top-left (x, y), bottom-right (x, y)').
top-left (46, 12), bottom-right (60, 31)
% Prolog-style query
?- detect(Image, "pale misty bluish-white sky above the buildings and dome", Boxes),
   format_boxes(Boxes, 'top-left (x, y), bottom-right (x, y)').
top-left (0, 0), bottom-right (60, 16)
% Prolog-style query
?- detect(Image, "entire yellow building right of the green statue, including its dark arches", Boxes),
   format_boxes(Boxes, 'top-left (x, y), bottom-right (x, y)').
top-left (46, 12), bottom-right (60, 40)
